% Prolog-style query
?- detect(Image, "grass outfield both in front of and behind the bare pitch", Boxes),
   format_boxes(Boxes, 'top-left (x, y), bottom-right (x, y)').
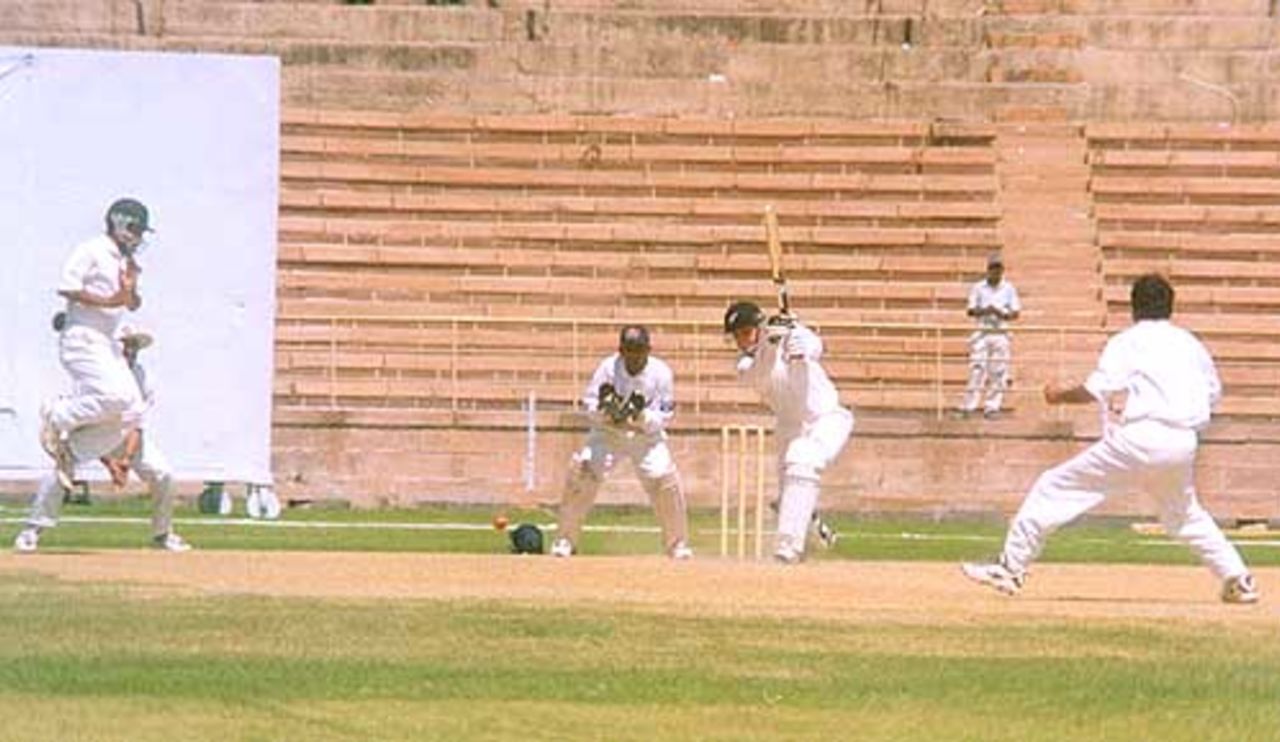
top-left (0, 501), bottom-right (1280, 742)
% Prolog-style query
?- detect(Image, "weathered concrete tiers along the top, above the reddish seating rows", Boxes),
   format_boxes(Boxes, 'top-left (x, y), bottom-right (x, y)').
top-left (0, 0), bottom-right (1280, 123)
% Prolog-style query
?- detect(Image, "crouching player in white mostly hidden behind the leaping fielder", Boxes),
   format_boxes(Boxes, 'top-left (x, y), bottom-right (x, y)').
top-left (13, 326), bottom-right (191, 553)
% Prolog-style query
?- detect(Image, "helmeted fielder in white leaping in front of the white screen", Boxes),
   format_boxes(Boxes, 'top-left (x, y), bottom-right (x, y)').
top-left (40, 198), bottom-right (151, 489)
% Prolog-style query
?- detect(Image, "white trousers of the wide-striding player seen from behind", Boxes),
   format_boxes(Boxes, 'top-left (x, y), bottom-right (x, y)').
top-left (1004, 421), bottom-right (1248, 580)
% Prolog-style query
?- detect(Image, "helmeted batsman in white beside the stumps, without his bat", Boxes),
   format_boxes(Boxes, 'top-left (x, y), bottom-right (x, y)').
top-left (724, 302), bottom-right (854, 564)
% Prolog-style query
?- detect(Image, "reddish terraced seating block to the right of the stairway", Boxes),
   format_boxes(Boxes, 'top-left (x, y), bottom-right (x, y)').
top-left (1087, 124), bottom-right (1280, 417)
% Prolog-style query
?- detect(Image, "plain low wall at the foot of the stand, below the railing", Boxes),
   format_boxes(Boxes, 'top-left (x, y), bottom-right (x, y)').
top-left (275, 413), bottom-right (1280, 518)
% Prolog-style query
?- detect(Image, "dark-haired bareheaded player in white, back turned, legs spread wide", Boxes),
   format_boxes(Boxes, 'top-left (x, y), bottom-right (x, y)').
top-left (963, 274), bottom-right (1260, 603)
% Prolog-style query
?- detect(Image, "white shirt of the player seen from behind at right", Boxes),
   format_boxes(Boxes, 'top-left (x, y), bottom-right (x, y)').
top-left (1084, 320), bottom-right (1222, 430)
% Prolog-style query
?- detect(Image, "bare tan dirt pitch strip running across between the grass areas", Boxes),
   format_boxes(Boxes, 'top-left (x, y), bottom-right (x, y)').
top-left (0, 550), bottom-right (1280, 627)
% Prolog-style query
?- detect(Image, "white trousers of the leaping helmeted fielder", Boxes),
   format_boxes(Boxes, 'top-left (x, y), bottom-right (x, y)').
top-left (51, 325), bottom-right (145, 432)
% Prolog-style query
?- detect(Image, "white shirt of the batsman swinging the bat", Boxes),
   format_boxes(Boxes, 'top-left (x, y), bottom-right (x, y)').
top-left (737, 324), bottom-right (841, 434)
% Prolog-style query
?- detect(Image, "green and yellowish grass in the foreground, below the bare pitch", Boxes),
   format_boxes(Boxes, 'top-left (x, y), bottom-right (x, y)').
top-left (0, 577), bottom-right (1280, 742)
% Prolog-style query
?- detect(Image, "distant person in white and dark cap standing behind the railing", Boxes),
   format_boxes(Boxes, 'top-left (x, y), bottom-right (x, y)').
top-left (960, 255), bottom-right (1023, 418)
